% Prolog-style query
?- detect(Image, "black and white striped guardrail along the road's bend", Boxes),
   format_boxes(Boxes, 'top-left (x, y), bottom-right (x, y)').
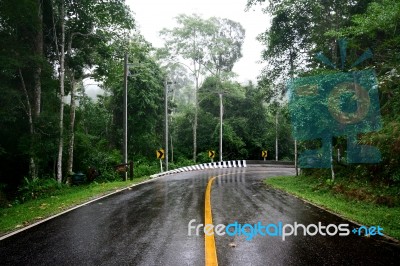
top-left (150, 160), bottom-right (247, 178)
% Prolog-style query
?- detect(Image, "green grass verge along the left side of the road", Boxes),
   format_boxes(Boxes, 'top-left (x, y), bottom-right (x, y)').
top-left (0, 177), bottom-right (148, 235)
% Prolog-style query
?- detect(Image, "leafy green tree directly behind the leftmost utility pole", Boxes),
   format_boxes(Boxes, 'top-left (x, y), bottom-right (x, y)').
top-left (104, 37), bottom-right (164, 158)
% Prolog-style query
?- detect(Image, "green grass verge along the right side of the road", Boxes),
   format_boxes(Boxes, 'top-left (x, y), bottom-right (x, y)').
top-left (265, 176), bottom-right (400, 240)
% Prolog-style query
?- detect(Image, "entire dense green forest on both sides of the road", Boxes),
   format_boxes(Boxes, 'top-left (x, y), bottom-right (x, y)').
top-left (0, 0), bottom-right (400, 201)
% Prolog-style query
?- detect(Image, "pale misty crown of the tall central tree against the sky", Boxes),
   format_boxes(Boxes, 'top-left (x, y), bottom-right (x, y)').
top-left (160, 14), bottom-right (245, 78)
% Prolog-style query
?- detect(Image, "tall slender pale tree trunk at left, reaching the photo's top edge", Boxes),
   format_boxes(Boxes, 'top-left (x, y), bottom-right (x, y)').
top-left (57, 1), bottom-right (65, 183)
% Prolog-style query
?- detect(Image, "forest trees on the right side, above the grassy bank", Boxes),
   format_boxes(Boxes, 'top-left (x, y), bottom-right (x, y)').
top-left (247, 0), bottom-right (400, 184)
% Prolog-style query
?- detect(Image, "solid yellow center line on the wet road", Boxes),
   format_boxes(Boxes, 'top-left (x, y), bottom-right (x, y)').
top-left (204, 176), bottom-right (218, 266)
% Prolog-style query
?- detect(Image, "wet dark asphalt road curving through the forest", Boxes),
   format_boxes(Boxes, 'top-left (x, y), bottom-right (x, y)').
top-left (0, 166), bottom-right (400, 265)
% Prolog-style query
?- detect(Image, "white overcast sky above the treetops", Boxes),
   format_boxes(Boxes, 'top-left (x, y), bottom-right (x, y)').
top-left (126, 0), bottom-right (270, 82)
